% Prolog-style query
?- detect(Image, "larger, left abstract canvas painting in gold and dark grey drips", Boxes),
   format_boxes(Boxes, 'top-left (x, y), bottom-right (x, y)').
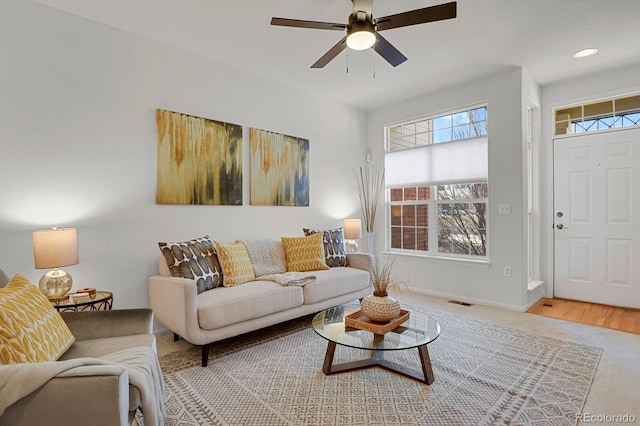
top-left (156, 109), bottom-right (242, 205)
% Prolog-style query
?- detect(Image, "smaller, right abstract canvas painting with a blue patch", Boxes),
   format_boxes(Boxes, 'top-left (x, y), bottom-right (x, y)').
top-left (249, 128), bottom-right (309, 206)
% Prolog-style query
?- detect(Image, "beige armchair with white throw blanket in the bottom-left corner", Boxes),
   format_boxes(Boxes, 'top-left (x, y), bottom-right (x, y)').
top-left (0, 272), bottom-right (164, 426)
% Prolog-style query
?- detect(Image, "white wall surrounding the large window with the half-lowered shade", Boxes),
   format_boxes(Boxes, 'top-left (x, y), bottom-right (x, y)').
top-left (369, 68), bottom-right (535, 309)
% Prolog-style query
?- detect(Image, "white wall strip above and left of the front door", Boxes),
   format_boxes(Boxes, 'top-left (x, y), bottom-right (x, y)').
top-left (541, 64), bottom-right (640, 296)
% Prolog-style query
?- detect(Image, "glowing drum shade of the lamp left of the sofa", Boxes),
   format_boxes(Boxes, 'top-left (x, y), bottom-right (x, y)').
top-left (32, 228), bottom-right (78, 269)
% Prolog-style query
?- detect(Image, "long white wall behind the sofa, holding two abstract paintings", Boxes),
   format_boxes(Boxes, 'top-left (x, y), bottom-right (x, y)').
top-left (0, 0), bottom-right (367, 308)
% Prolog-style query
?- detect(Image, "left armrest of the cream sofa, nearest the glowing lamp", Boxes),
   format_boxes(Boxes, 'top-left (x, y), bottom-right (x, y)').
top-left (149, 275), bottom-right (201, 345)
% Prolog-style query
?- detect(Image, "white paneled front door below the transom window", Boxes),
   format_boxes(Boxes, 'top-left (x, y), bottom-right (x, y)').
top-left (553, 129), bottom-right (640, 308)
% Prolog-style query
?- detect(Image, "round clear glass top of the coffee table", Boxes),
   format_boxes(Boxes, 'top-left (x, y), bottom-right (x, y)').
top-left (312, 304), bottom-right (440, 351)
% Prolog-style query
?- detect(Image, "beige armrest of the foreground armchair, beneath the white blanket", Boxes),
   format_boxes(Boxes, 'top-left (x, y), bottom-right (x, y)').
top-left (0, 365), bottom-right (130, 426)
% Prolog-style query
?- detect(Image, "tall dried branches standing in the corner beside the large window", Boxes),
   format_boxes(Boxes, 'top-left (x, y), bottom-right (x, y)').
top-left (356, 164), bottom-right (384, 253)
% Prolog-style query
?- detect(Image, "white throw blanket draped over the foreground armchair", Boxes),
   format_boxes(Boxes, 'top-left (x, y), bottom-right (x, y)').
top-left (0, 346), bottom-right (165, 426)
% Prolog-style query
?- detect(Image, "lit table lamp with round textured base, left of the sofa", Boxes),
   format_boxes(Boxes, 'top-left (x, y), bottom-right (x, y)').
top-left (32, 226), bottom-right (78, 299)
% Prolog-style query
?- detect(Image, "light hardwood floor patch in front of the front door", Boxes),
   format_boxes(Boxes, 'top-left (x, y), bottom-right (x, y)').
top-left (527, 298), bottom-right (640, 334)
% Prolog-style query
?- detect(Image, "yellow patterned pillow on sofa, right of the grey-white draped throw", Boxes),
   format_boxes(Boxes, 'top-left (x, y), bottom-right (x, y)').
top-left (281, 234), bottom-right (329, 272)
